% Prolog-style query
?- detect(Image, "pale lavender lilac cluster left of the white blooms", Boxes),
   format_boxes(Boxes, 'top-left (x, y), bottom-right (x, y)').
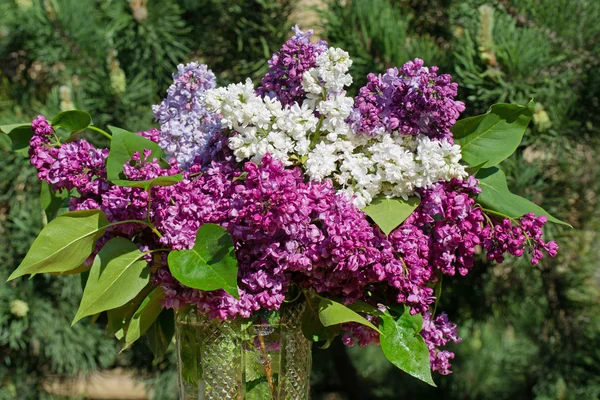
top-left (152, 62), bottom-right (223, 169)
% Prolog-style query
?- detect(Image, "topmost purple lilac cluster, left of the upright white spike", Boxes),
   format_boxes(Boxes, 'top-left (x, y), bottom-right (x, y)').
top-left (256, 25), bottom-right (328, 105)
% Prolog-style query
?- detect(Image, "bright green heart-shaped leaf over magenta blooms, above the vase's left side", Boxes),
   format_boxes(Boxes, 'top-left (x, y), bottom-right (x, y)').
top-left (169, 224), bottom-right (239, 299)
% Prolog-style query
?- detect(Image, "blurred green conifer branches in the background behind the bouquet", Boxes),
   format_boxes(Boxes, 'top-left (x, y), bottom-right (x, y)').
top-left (0, 0), bottom-right (600, 400)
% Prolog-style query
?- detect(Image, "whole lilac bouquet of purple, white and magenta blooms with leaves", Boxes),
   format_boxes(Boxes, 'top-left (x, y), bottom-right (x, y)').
top-left (5, 28), bottom-right (564, 384)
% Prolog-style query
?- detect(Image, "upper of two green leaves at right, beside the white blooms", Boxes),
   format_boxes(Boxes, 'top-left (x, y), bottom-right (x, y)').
top-left (451, 100), bottom-right (533, 168)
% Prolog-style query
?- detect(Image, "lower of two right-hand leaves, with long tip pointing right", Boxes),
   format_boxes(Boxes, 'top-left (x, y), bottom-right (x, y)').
top-left (476, 167), bottom-right (572, 228)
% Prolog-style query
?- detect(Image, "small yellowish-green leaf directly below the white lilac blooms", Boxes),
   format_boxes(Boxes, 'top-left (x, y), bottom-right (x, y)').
top-left (363, 196), bottom-right (421, 235)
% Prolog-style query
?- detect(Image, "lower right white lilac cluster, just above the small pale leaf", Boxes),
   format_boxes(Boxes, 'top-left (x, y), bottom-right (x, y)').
top-left (305, 133), bottom-right (467, 208)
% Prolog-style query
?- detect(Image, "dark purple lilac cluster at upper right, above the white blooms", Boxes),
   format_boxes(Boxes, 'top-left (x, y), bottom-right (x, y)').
top-left (349, 58), bottom-right (465, 139)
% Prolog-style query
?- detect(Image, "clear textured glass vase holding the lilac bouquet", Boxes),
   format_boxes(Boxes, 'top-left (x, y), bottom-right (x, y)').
top-left (175, 303), bottom-right (311, 400)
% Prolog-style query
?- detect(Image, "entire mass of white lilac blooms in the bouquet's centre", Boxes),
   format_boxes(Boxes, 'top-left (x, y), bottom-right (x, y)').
top-left (202, 48), bottom-right (467, 208)
